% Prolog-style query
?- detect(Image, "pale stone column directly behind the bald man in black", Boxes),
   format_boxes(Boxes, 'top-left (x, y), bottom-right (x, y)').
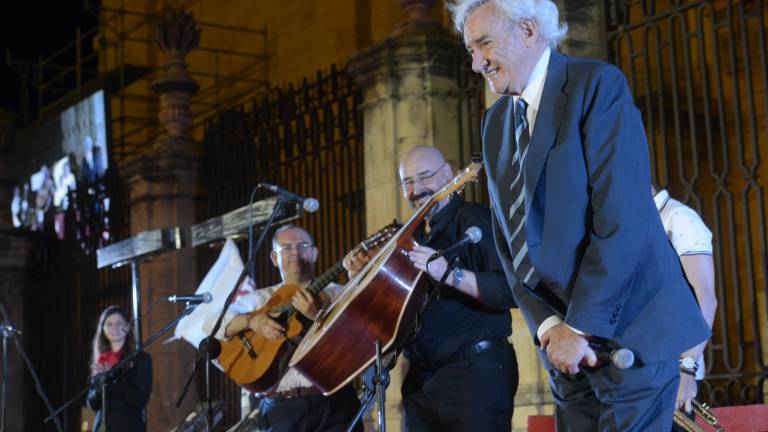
top-left (347, 0), bottom-right (474, 431)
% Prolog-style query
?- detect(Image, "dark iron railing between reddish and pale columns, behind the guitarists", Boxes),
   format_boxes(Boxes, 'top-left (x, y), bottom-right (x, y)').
top-left (198, 68), bottom-right (366, 423)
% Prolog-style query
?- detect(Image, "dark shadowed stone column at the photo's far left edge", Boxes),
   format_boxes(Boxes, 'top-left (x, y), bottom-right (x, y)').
top-left (0, 112), bottom-right (35, 430)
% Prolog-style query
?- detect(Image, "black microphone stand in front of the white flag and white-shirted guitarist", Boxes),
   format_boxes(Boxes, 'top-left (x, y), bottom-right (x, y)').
top-left (176, 197), bottom-right (284, 432)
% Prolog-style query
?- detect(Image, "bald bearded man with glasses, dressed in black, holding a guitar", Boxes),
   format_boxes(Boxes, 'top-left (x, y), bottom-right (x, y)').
top-left (345, 146), bottom-right (518, 432)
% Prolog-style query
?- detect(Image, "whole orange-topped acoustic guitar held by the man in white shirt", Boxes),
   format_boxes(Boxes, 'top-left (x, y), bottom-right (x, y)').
top-left (217, 222), bottom-right (400, 393)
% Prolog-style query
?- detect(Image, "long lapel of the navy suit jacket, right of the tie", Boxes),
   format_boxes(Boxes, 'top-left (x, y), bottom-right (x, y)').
top-left (524, 50), bottom-right (567, 214)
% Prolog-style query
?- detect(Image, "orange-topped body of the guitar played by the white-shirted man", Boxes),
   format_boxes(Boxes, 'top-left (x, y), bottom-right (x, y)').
top-left (218, 285), bottom-right (304, 393)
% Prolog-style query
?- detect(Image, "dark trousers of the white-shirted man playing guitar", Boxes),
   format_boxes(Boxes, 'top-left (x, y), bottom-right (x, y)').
top-left (259, 385), bottom-right (363, 432)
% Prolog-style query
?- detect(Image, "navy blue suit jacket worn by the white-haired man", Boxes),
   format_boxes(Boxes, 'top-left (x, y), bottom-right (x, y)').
top-left (482, 50), bottom-right (710, 363)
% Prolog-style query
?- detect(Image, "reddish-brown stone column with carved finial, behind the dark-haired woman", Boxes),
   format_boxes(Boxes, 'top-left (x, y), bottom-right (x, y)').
top-left (120, 9), bottom-right (200, 430)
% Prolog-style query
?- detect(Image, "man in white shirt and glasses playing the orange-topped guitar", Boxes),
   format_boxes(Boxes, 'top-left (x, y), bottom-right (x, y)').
top-left (217, 225), bottom-right (362, 432)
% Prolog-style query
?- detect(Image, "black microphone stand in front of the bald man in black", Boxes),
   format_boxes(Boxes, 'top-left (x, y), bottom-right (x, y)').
top-left (346, 254), bottom-right (459, 432)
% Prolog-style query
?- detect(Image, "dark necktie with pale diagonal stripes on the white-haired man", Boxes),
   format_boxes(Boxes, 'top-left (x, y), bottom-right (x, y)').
top-left (509, 98), bottom-right (539, 288)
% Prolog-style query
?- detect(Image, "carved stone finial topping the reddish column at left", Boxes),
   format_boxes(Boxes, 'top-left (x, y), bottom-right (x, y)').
top-left (152, 8), bottom-right (201, 154)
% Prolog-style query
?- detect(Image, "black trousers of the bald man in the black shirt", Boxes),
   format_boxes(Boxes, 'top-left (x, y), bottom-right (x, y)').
top-left (402, 345), bottom-right (518, 432)
